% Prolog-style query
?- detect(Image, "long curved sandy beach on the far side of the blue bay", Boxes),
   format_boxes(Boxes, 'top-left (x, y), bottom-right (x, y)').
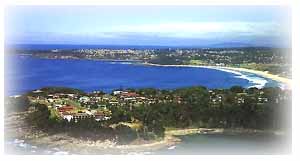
top-left (142, 63), bottom-right (292, 89)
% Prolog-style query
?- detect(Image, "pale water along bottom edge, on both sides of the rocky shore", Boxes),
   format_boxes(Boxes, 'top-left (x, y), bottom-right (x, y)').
top-left (5, 134), bottom-right (291, 155)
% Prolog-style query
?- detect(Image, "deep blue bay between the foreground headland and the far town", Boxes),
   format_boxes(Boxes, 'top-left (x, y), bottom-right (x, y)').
top-left (5, 56), bottom-right (278, 95)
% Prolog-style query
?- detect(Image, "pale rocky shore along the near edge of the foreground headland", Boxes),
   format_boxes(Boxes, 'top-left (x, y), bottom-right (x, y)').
top-left (6, 128), bottom-right (284, 155)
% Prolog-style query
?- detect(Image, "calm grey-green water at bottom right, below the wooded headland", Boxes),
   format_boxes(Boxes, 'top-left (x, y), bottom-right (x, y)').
top-left (156, 134), bottom-right (291, 155)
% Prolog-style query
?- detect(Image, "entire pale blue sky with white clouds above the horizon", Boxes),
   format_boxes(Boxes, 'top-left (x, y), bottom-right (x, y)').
top-left (5, 6), bottom-right (291, 46)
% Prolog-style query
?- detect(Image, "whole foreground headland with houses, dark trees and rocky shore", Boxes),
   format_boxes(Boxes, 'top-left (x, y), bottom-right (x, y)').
top-left (5, 86), bottom-right (291, 154)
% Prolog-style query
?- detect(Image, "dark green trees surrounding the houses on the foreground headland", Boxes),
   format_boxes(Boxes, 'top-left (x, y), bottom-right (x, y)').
top-left (11, 86), bottom-right (292, 143)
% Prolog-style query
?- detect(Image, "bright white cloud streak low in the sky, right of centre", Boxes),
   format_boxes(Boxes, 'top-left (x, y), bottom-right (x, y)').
top-left (111, 21), bottom-right (284, 38)
